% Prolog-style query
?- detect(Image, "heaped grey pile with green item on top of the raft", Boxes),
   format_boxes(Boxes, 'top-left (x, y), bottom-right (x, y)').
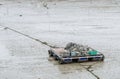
top-left (65, 42), bottom-right (97, 56)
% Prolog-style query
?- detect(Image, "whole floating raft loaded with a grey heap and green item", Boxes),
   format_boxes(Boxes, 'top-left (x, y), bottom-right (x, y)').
top-left (48, 42), bottom-right (104, 64)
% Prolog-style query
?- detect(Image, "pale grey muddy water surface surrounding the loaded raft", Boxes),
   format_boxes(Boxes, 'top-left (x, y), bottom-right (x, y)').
top-left (0, 0), bottom-right (120, 79)
